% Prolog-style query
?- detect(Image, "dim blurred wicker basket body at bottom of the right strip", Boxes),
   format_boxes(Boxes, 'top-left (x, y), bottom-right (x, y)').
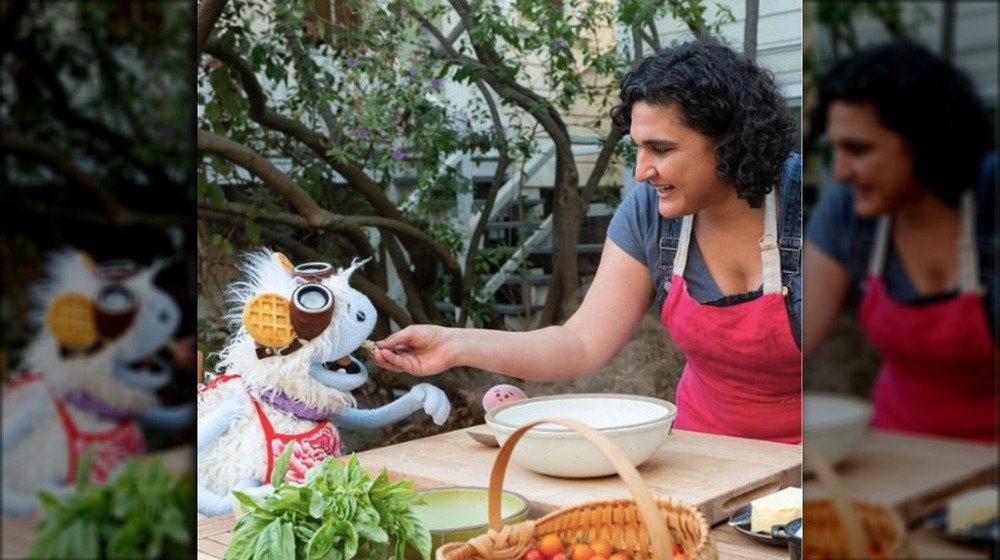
top-left (802, 499), bottom-right (913, 559)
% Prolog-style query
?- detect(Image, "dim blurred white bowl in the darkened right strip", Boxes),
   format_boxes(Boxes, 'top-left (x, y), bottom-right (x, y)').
top-left (802, 392), bottom-right (872, 472)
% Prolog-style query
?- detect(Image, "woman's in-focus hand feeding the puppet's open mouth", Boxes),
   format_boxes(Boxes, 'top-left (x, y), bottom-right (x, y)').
top-left (369, 325), bottom-right (457, 377)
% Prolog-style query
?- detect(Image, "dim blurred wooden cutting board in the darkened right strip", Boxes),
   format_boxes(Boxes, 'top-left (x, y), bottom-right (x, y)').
top-left (804, 430), bottom-right (997, 523)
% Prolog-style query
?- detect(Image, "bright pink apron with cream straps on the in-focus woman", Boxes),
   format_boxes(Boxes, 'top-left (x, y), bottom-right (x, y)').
top-left (660, 192), bottom-right (802, 443)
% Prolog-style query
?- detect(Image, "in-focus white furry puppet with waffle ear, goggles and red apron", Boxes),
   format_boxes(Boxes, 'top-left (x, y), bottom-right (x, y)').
top-left (198, 249), bottom-right (451, 516)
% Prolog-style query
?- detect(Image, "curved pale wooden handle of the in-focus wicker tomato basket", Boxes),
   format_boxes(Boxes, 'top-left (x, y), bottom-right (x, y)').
top-left (488, 418), bottom-right (673, 560)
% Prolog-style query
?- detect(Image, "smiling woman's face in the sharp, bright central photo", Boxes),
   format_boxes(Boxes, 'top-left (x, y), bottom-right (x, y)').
top-left (629, 101), bottom-right (736, 218)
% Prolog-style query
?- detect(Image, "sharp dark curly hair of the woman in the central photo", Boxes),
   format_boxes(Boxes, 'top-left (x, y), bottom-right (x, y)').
top-left (611, 39), bottom-right (797, 208)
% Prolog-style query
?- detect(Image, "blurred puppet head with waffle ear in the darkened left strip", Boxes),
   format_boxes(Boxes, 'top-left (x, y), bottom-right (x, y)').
top-left (25, 250), bottom-right (180, 398)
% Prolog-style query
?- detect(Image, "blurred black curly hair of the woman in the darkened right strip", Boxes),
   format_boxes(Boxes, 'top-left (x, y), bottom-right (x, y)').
top-left (810, 39), bottom-right (991, 206)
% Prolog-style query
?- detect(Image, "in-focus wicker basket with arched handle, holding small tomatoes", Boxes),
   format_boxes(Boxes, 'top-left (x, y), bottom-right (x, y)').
top-left (435, 418), bottom-right (718, 560)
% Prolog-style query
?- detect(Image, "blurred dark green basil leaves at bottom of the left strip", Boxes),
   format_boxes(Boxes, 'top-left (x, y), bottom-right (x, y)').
top-left (28, 448), bottom-right (195, 560)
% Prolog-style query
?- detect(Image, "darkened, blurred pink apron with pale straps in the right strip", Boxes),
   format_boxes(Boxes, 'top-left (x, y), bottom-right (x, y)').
top-left (858, 193), bottom-right (997, 442)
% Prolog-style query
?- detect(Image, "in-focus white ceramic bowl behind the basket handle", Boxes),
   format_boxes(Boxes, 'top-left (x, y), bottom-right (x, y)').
top-left (486, 393), bottom-right (677, 478)
